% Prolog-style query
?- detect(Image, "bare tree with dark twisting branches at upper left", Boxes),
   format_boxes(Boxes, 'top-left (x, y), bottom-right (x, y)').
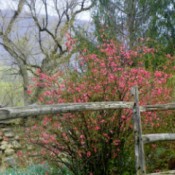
top-left (0, 0), bottom-right (93, 105)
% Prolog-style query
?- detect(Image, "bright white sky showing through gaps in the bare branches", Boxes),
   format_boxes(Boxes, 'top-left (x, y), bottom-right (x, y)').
top-left (0, 0), bottom-right (91, 20)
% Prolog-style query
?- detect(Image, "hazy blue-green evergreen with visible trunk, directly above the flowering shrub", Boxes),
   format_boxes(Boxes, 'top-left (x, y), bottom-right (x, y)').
top-left (93, 0), bottom-right (148, 48)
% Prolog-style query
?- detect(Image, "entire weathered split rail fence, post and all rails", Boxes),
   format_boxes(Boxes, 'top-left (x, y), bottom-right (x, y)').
top-left (0, 87), bottom-right (175, 175)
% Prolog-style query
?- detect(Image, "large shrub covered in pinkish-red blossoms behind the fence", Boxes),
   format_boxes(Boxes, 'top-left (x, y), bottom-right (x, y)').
top-left (29, 38), bottom-right (174, 175)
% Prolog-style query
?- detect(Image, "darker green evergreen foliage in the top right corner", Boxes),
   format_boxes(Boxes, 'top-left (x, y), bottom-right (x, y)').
top-left (143, 0), bottom-right (175, 54)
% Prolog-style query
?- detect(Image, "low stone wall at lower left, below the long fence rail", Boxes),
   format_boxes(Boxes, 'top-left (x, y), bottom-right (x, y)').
top-left (0, 117), bottom-right (39, 170)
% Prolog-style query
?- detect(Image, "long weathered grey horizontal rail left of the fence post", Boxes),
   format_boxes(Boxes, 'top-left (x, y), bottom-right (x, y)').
top-left (0, 101), bottom-right (134, 121)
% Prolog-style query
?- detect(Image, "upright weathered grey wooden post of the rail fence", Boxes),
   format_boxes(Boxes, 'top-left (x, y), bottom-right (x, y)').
top-left (131, 86), bottom-right (146, 175)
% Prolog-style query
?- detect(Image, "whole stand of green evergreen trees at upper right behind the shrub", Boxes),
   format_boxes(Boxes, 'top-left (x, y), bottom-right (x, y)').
top-left (92, 0), bottom-right (175, 54)
